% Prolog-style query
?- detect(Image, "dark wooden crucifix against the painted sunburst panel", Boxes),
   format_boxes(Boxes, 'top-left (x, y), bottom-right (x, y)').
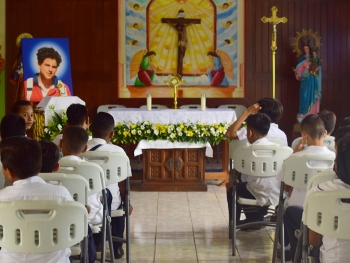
top-left (161, 9), bottom-right (201, 76)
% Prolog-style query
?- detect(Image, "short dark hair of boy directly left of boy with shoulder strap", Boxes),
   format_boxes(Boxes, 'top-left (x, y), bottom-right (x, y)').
top-left (62, 125), bottom-right (89, 155)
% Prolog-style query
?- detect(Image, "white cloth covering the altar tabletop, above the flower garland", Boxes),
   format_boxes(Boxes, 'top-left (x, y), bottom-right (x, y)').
top-left (108, 108), bottom-right (237, 124)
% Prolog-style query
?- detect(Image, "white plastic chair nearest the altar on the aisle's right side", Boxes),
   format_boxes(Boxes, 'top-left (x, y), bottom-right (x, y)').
top-left (231, 144), bottom-right (293, 256)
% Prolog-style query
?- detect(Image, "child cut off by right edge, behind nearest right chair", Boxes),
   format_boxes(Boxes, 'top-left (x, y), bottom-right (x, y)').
top-left (307, 136), bottom-right (350, 263)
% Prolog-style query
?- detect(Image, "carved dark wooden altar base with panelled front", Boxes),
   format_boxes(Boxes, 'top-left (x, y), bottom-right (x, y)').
top-left (140, 148), bottom-right (207, 191)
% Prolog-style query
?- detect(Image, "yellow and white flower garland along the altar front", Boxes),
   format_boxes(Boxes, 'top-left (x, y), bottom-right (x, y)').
top-left (111, 121), bottom-right (230, 145)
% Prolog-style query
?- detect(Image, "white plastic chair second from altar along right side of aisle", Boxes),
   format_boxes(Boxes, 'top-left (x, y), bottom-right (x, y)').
top-left (272, 154), bottom-right (334, 262)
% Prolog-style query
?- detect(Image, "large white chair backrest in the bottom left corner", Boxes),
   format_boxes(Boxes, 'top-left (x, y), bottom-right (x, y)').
top-left (0, 200), bottom-right (88, 254)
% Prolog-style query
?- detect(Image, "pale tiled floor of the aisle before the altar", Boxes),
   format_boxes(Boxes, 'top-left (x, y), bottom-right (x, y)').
top-left (108, 185), bottom-right (288, 263)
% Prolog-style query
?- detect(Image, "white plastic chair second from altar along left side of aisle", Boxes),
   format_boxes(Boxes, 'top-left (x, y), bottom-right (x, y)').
top-left (58, 159), bottom-right (114, 263)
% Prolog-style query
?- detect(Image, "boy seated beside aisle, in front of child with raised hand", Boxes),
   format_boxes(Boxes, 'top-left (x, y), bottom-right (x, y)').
top-left (236, 113), bottom-right (280, 225)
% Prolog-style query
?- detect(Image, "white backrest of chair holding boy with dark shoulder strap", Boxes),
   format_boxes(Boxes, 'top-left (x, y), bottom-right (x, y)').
top-left (80, 151), bottom-right (130, 185)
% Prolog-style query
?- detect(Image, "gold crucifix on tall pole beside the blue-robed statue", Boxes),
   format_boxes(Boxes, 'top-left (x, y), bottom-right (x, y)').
top-left (261, 6), bottom-right (288, 98)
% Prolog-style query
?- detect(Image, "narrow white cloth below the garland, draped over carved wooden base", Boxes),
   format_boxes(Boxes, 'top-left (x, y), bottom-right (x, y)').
top-left (134, 140), bottom-right (213, 157)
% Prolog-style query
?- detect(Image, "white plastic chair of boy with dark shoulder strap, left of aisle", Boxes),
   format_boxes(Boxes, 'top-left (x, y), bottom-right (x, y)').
top-left (80, 151), bottom-right (131, 262)
